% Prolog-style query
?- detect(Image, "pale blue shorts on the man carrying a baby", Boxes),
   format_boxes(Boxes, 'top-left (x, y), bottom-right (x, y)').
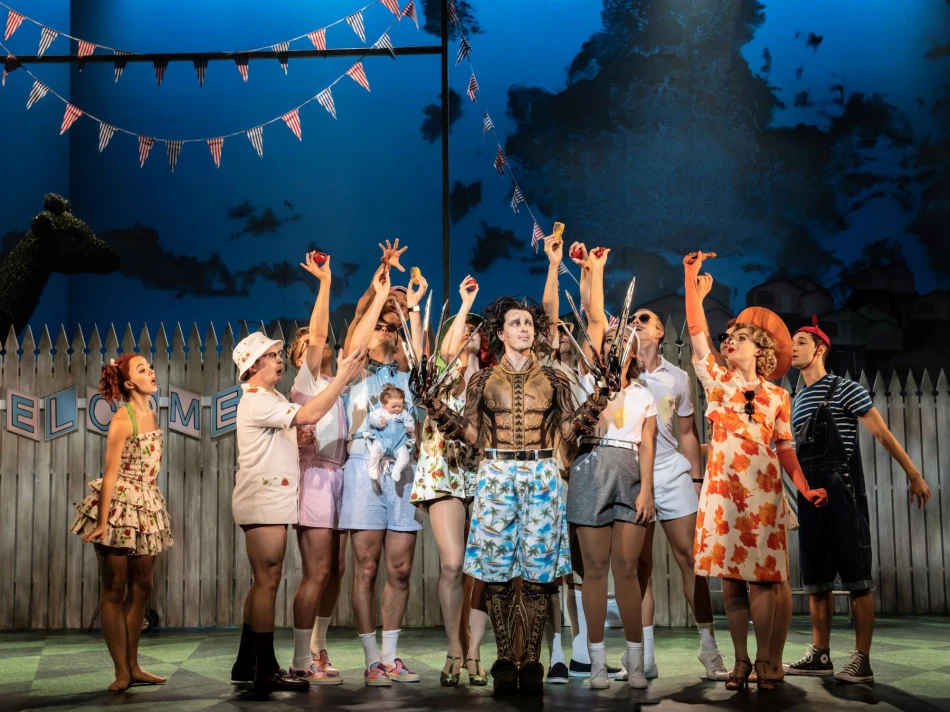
top-left (340, 453), bottom-right (422, 532)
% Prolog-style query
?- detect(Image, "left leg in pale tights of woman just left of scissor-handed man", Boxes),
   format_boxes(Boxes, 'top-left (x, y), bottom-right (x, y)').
top-left (429, 497), bottom-right (465, 673)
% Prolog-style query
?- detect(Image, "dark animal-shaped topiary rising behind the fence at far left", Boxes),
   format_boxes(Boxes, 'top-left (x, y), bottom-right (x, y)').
top-left (0, 193), bottom-right (120, 337)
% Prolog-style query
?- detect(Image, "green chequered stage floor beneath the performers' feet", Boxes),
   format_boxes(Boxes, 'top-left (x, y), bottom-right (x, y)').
top-left (0, 616), bottom-right (950, 712)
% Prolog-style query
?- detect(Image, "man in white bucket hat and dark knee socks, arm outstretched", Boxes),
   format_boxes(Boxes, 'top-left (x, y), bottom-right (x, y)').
top-left (231, 332), bottom-right (366, 691)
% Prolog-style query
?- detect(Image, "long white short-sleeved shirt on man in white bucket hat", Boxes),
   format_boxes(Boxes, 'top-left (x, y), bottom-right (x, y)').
top-left (231, 383), bottom-right (300, 524)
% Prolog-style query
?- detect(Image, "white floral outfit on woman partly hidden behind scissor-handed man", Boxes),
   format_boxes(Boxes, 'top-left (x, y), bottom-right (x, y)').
top-left (409, 368), bottom-right (479, 504)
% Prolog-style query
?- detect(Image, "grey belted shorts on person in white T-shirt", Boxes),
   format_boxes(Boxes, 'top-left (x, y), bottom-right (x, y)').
top-left (567, 445), bottom-right (640, 527)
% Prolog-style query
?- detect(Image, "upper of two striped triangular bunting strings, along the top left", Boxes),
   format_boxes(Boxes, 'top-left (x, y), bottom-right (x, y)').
top-left (0, 0), bottom-right (419, 86)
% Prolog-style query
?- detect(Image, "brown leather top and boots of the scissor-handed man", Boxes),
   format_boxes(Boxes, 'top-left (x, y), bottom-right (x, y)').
top-left (429, 354), bottom-right (607, 693)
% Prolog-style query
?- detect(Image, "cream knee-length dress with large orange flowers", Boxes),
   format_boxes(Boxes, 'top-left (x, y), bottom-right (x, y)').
top-left (693, 354), bottom-right (792, 582)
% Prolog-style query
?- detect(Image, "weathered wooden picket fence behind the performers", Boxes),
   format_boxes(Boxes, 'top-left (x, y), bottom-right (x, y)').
top-left (0, 323), bottom-right (950, 629)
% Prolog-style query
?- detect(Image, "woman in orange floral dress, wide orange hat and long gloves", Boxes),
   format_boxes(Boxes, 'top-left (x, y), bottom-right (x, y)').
top-left (683, 252), bottom-right (827, 690)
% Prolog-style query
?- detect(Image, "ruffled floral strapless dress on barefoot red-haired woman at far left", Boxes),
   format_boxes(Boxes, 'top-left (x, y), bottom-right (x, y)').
top-left (70, 405), bottom-right (174, 556)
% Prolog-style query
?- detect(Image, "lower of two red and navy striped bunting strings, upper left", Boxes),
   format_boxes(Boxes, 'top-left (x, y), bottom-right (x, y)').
top-left (0, 0), bottom-right (418, 172)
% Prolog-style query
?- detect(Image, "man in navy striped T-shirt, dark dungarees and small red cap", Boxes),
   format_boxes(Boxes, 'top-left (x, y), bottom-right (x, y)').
top-left (785, 317), bottom-right (930, 682)
